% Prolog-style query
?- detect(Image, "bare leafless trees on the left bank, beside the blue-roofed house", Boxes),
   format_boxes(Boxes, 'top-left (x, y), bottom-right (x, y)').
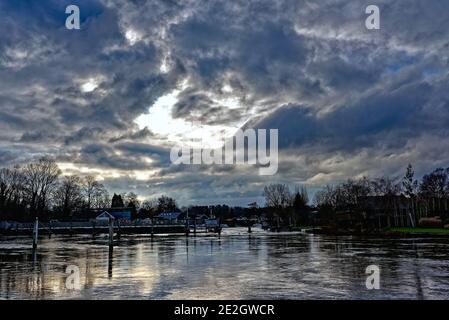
top-left (0, 157), bottom-right (110, 220)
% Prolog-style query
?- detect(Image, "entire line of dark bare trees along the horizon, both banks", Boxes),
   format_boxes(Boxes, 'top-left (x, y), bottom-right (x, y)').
top-left (0, 157), bottom-right (449, 224)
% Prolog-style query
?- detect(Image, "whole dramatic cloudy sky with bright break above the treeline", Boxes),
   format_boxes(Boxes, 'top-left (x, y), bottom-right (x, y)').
top-left (0, 0), bottom-right (449, 205)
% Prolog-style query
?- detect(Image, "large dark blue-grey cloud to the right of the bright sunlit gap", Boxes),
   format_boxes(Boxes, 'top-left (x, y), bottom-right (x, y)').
top-left (255, 82), bottom-right (440, 151)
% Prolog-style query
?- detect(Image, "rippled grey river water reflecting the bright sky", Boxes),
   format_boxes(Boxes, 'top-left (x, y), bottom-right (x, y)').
top-left (0, 228), bottom-right (449, 299)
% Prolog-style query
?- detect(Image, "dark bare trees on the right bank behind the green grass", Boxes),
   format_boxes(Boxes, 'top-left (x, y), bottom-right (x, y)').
top-left (263, 164), bottom-right (449, 224)
